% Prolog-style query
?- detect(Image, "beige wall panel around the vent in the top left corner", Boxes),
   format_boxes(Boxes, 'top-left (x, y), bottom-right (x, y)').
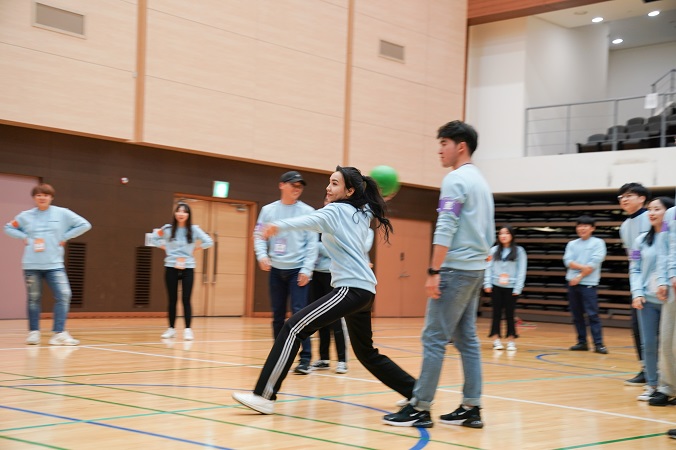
top-left (0, 0), bottom-right (136, 139)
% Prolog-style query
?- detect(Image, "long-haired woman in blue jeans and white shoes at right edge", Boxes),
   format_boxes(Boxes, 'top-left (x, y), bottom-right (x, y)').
top-left (629, 197), bottom-right (674, 402)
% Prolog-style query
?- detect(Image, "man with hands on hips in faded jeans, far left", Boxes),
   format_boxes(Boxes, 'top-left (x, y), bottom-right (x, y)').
top-left (5, 184), bottom-right (92, 345)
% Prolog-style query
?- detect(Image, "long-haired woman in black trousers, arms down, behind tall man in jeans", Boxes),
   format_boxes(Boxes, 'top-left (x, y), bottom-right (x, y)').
top-left (484, 225), bottom-right (528, 351)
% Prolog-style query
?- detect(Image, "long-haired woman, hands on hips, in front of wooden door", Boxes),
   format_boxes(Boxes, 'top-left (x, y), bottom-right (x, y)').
top-left (152, 203), bottom-right (214, 341)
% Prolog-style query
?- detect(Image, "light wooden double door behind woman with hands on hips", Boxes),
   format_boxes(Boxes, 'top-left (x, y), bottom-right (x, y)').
top-left (176, 196), bottom-right (253, 316)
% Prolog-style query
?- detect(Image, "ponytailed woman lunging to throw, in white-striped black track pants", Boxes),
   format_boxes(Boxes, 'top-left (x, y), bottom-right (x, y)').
top-left (232, 166), bottom-right (415, 414)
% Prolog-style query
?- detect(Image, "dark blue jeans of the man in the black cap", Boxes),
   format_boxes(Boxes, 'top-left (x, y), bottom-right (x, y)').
top-left (270, 267), bottom-right (312, 364)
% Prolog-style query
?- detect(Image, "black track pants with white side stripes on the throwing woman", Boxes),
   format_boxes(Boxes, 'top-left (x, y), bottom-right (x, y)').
top-left (254, 287), bottom-right (415, 400)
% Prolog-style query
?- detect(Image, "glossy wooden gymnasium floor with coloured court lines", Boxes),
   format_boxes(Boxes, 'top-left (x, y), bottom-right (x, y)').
top-left (0, 318), bottom-right (676, 450)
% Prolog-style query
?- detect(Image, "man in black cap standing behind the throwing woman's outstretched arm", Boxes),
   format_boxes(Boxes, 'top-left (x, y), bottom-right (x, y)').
top-left (254, 170), bottom-right (319, 375)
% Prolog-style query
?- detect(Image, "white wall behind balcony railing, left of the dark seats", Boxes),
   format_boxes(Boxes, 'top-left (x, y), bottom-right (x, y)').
top-left (525, 17), bottom-right (613, 156)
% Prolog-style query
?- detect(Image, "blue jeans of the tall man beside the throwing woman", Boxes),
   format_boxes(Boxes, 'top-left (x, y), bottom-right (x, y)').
top-left (411, 269), bottom-right (484, 411)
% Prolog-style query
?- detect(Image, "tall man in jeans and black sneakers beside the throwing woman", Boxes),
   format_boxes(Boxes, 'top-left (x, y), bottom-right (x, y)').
top-left (383, 120), bottom-right (495, 428)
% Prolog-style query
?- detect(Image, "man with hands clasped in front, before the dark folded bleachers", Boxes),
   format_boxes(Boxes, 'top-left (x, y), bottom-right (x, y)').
top-left (563, 216), bottom-right (608, 355)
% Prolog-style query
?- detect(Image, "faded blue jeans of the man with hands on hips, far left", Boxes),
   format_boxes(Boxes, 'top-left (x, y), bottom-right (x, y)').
top-left (23, 269), bottom-right (71, 333)
